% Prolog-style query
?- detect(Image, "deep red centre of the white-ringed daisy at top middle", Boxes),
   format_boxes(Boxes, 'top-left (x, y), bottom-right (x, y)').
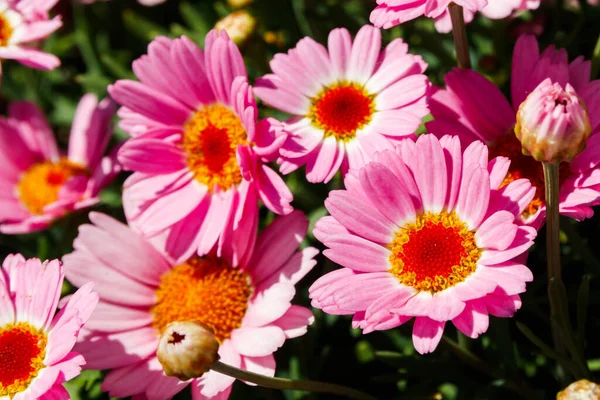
top-left (308, 82), bottom-right (375, 141)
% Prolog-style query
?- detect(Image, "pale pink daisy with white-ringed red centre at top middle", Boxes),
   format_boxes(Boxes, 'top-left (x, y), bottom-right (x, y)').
top-left (254, 25), bottom-right (430, 182)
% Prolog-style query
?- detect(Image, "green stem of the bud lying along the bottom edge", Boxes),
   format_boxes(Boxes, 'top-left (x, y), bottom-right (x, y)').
top-left (211, 361), bottom-right (377, 400)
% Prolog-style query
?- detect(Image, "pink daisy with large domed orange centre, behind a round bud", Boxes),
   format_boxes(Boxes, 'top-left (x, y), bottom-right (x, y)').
top-left (63, 211), bottom-right (318, 400)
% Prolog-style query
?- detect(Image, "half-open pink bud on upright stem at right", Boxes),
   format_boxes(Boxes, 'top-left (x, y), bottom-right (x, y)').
top-left (515, 79), bottom-right (592, 162)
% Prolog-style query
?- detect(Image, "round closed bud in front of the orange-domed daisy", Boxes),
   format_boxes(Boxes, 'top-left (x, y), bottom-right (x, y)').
top-left (156, 321), bottom-right (219, 381)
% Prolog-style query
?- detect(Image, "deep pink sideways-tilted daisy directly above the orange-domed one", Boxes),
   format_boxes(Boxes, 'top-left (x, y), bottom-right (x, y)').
top-left (109, 30), bottom-right (292, 262)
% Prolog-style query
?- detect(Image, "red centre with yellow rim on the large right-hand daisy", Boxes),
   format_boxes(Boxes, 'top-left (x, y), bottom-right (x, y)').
top-left (389, 211), bottom-right (481, 293)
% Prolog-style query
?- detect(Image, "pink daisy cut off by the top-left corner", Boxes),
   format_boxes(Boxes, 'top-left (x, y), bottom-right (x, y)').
top-left (0, 0), bottom-right (62, 79)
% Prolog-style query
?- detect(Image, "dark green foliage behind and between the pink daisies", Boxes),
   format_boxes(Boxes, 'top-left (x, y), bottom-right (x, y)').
top-left (0, 0), bottom-right (600, 400)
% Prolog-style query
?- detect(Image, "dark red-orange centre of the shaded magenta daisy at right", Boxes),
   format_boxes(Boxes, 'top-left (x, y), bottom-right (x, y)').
top-left (489, 131), bottom-right (570, 218)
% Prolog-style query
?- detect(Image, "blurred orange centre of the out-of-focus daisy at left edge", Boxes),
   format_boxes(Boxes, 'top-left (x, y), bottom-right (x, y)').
top-left (17, 158), bottom-right (90, 215)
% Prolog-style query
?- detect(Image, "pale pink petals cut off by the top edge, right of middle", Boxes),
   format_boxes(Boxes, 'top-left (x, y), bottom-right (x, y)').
top-left (371, 0), bottom-right (541, 33)
